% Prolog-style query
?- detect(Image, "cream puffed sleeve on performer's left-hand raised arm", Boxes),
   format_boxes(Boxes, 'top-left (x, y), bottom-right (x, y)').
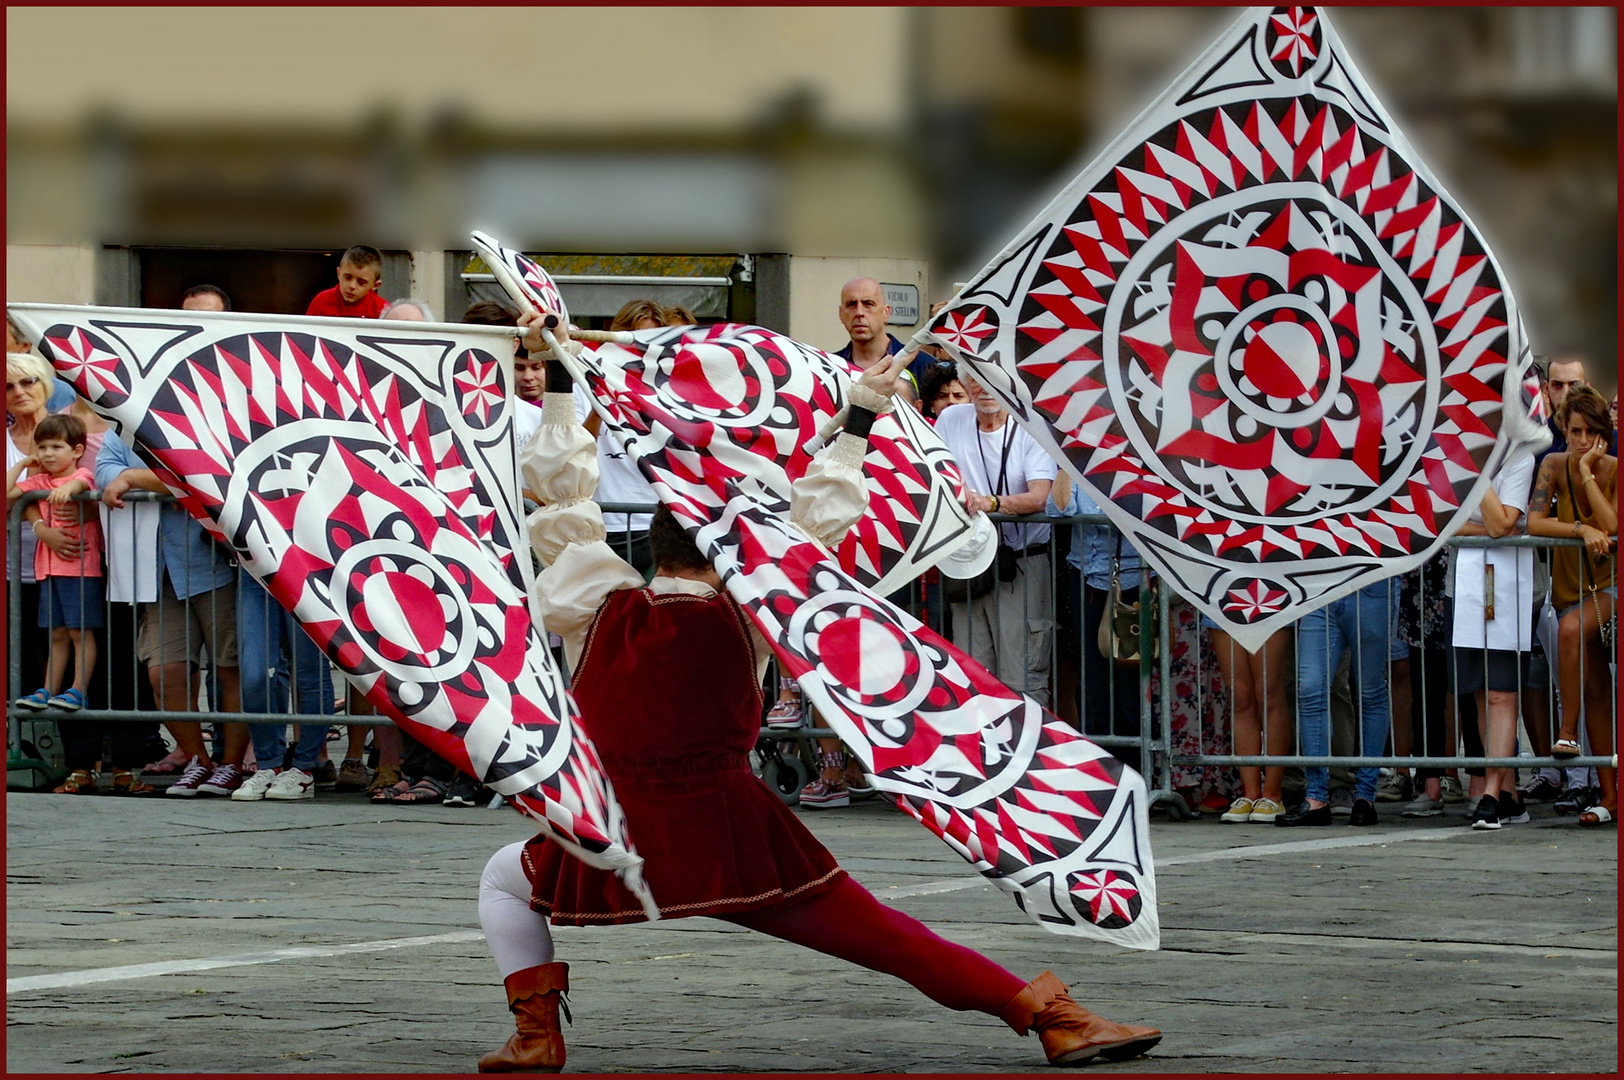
top-left (520, 393), bottom-right (643, 667)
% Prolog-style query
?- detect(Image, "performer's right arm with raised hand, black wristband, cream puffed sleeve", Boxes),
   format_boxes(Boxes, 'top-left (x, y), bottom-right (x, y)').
top-left (789, 352), bottom-right (913, 547)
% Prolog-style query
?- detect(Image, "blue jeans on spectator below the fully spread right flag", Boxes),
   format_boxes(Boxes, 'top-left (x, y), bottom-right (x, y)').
top-left (1298, 578), bottom-right (1398, 802)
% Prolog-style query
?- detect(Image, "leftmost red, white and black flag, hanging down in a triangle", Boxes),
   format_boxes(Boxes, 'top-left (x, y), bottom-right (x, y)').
top-left (6, 304), bottom-right (646, 909)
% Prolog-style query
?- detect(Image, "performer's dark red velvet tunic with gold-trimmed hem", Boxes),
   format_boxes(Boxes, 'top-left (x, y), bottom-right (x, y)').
top-left (525, 588), bottom-right (846, 926)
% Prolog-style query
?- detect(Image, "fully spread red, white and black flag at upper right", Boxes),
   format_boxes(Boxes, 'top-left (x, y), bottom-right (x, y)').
top-left (916, 8), bottom-right (1548, 648)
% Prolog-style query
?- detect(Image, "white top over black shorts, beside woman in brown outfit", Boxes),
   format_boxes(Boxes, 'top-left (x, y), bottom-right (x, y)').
top-left (1455, 453), bottom-right (1533, 651)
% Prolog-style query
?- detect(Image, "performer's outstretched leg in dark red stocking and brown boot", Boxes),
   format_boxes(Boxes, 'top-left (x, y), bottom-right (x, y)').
top-left (719, 877), bottom-right (1161, 1064)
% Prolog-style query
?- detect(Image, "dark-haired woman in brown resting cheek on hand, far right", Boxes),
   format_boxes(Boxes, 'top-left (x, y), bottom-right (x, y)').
top-left (1528, 385), bottom-right (1619, 825)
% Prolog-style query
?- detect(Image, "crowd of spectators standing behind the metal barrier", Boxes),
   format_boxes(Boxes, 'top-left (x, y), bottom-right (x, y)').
top-left (6, 263), bottom-right (1618, 830)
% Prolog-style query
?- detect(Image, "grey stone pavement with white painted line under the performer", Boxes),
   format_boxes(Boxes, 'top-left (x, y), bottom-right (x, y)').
top-left (6, 782), bottom-right (1619, 1074)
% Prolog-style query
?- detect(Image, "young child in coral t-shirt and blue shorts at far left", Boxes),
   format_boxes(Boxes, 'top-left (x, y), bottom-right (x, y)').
top-left (6, 413), bottom-right (104, 713)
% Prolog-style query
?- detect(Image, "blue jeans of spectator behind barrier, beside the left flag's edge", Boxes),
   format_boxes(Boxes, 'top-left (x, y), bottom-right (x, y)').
top-left (237, 570), bottom-right (333, 773)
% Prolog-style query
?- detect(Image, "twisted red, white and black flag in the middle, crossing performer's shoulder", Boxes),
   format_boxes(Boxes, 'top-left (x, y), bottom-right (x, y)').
top-left (476, 237), bottom-right (1160, 948)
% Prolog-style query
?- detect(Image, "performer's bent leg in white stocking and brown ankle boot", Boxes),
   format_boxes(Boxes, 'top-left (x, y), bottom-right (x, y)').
top-left (479, 843), bottom-right (570, 1072)
